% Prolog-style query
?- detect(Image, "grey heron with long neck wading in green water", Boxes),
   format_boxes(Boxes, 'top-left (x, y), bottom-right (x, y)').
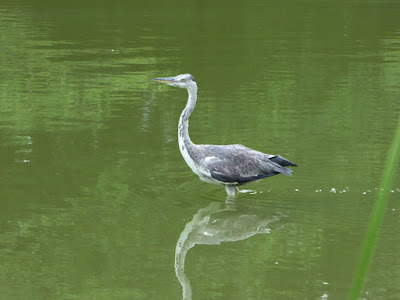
top-left (153, 74), bottom-right (297, 196)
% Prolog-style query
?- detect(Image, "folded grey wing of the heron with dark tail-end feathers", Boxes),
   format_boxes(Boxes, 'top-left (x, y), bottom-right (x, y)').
top-left (199, 145), bottom-right (294, 184)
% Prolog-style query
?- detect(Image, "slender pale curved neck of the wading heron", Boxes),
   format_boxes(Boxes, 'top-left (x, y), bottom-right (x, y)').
top-left (178, 82), bottom-right (197, 148)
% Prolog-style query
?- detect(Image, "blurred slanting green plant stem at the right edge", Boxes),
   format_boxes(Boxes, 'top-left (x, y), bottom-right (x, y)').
top-left (350, 116), bottom-right (400, 300)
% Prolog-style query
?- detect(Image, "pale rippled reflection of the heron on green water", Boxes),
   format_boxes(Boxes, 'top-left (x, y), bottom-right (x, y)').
top-left (175, 201), bottom-right (287, 300)
